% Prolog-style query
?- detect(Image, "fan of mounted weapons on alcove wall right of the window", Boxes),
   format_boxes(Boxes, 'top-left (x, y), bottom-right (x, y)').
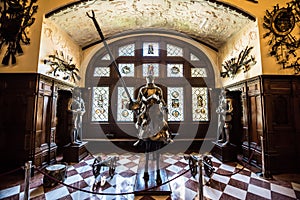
top-left (221, 46), bottom-right (256, 78)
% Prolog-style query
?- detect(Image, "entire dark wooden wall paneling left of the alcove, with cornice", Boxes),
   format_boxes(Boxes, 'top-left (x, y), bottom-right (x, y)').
top-left (0, 73), bottom-right (72, 171)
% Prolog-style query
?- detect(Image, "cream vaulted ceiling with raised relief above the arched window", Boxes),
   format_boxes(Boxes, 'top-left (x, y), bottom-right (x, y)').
top-left (46, 0), bottom-right (254, 49)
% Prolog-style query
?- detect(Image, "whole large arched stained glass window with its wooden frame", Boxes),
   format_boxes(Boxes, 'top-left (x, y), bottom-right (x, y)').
top-left (86, 35), bottom-right (214, 138)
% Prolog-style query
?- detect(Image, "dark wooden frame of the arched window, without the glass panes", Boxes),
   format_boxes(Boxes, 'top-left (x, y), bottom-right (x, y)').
top-left (86, 35), bottom-right (215, 138)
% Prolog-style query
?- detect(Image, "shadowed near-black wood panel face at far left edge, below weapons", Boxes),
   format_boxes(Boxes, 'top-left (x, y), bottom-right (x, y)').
top-left (0, 74), bottom-right (36, 171)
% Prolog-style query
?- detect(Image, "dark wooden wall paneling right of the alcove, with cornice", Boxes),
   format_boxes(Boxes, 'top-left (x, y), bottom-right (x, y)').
top-left (229, 75), bottom-right (300, 174)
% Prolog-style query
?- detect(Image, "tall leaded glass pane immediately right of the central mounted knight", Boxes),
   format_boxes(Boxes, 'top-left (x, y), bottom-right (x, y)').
top-left (167, 87), bottom-right (184, 121)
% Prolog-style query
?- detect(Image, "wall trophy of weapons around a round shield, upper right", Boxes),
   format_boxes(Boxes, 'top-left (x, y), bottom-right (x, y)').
top-left (263, 0), bottom-right (300, 74)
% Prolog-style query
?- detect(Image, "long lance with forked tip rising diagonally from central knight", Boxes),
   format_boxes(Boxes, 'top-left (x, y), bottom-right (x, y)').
top-left (86, 10), bottom-right (132, 102)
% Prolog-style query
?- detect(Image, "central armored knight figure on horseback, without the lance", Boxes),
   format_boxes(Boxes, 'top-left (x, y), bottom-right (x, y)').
top-left (129, 75), bottom-right (172, 184)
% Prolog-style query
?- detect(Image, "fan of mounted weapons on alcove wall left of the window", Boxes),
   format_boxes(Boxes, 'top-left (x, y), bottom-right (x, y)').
top-left (44, 51), bottom-right (80, 83)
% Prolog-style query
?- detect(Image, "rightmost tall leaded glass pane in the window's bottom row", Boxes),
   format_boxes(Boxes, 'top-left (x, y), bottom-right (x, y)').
top-left (192, 87), bottom-right (208, 121)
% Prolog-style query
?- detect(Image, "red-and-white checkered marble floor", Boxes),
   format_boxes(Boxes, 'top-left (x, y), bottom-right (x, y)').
top-left (0, 153), bottom-right (300, 200)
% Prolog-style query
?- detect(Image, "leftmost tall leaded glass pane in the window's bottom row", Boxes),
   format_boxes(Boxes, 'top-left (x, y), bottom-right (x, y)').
top-left (92, 87), bottom-right (109, 121)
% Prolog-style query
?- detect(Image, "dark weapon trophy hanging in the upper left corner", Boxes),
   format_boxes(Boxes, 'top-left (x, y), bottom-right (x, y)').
top-left (0, 0), bottom-right (38, 65)
